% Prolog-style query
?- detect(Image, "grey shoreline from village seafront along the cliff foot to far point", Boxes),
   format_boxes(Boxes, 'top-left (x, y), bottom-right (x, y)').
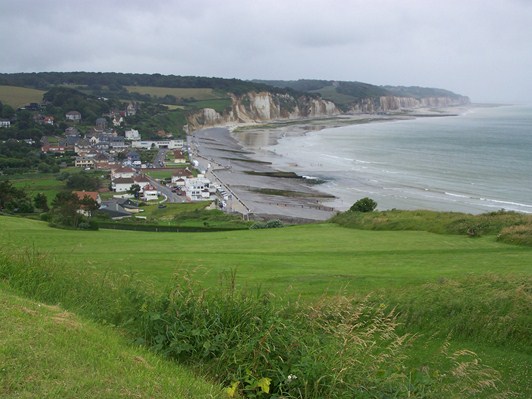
top-left (189, 107), bottom-right (465, 223)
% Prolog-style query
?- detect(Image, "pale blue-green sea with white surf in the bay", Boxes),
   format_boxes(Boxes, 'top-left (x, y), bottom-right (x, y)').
top-left (254, 106), bottom-right (532, 213)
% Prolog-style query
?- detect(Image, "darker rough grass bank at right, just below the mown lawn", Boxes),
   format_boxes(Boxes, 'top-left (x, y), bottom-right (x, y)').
top-left (388, 274), bottom-right (532, 353)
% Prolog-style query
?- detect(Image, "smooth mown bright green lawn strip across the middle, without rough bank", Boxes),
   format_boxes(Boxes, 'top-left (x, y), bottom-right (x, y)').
top-left (0, 217), bottom-right (532, 297)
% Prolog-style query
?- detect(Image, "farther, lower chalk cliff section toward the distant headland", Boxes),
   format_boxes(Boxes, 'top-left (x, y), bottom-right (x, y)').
top-left (350, 96), bottom-right (469, 113)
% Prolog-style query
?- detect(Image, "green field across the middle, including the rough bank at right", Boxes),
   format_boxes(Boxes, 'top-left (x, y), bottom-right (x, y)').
top-left (0, 217), bottom-right (532, 398)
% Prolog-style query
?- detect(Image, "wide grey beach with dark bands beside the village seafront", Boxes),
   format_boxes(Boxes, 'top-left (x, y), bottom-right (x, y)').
top-left (189, 128), bottom-right (335, 222)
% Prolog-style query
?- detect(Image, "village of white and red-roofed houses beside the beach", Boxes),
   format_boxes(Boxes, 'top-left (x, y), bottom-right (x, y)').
top-left (34, 104), bottom-right (228, 220)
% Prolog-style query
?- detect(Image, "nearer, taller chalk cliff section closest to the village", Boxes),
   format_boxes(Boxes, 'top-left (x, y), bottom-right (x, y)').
top-left (188, 92), bottom-right (341, 130)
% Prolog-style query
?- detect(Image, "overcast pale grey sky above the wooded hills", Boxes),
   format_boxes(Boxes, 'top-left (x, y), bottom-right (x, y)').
top-left (0, 0), bottom-right (532, 103)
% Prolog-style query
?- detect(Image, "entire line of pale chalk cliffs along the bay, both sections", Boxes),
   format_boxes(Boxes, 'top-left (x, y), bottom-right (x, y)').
top-left (187, 91), bottom-right (469, 130)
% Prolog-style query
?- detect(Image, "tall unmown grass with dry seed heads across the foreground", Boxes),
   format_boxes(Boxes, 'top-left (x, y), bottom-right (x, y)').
top-left (0, 251), bottom-right (516, 398)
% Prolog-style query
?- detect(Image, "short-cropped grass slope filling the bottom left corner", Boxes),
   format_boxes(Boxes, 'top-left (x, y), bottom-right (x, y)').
top-left (0, 283), bottom-right (221, 398)
